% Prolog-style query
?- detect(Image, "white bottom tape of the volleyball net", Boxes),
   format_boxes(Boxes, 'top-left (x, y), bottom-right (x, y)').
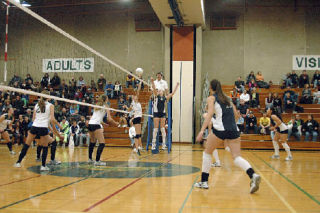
top-left (0, 85), bottom-right (153, 117)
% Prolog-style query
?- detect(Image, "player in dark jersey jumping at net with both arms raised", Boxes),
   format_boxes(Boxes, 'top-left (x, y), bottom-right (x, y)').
top-left (151, 78), bottom-right (179, 150)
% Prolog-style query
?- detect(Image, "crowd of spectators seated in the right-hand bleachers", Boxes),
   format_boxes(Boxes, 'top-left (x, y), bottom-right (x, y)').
top-left (230, 71), bottom-right (320, 141)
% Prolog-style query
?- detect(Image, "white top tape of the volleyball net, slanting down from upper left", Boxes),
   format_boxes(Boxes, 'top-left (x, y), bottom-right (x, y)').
top-left (7, 0), bottom-right (151, 87)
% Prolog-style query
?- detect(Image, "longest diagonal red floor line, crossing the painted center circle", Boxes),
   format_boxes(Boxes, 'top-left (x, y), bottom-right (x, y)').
top-left (83, 152), bottom-right (183, 212)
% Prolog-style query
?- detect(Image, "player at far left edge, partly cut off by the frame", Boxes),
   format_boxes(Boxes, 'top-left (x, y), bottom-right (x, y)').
top-left (0, 108), bottom-right (16, 155)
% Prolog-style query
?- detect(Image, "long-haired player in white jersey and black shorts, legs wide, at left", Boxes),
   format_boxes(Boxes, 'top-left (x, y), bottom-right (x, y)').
top-left (14, 91), bottom-right (62, 171)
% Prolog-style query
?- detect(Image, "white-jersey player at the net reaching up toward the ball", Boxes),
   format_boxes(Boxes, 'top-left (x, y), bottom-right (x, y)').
top-left (130, 82), bottom-right (142, 155)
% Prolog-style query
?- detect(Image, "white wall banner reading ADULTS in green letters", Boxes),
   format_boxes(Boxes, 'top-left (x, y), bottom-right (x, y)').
top-left (42, 58), bottom-right (94, 72)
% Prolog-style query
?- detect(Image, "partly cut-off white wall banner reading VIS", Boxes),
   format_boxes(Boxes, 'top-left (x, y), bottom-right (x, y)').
top-left (292, 55), bottom-right (320, 70)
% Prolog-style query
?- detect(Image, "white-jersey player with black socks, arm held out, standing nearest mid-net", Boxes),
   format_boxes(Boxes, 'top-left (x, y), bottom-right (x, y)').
top-left (88, 95), bottom-right (119, 166)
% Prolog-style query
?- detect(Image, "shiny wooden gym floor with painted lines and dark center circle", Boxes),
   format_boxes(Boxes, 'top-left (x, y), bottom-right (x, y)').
top-left (0, 145), bottom-right (320, 213)
